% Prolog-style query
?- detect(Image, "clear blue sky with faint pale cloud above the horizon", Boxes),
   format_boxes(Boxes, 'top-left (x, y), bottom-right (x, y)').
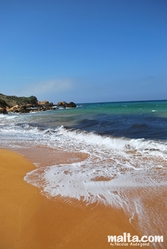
top-left (0, 0), bottom-right (167, 103)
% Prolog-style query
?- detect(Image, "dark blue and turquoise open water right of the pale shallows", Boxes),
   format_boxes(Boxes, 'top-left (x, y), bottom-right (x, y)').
top-left (58, 101), bottom-right (167, 140)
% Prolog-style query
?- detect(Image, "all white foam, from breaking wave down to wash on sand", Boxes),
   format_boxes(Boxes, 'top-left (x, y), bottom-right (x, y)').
top-left (0, 117), bottom-right (167, 207)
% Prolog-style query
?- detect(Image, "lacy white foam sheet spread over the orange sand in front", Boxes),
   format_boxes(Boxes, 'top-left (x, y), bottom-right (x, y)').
top-left (25, 159), bottom-right (167, 204)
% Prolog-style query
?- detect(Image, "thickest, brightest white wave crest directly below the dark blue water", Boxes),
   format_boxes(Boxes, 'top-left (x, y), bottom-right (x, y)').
top-left (57, 127), bottom-right (167, 155)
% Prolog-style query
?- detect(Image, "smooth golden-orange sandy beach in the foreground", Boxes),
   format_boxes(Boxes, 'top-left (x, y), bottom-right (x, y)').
top-left (0, 149), bottom-right (164, 249)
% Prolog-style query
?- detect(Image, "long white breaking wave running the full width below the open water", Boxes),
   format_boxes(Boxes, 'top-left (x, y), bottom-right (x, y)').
top-left (0, 122), bottom-right (167, 159)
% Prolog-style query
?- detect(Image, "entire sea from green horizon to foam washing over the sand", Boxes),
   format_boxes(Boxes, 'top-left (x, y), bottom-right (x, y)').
top-left (0, 100), bottom-right (167, 247)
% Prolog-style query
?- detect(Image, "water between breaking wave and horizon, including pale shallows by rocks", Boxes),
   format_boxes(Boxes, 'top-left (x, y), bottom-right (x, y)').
top-left (0, 98), bottom-right (167, 141)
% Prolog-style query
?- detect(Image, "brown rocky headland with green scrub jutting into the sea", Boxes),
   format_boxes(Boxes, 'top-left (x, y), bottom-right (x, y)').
top-left (0, 94), bottom-right (76, 114)
